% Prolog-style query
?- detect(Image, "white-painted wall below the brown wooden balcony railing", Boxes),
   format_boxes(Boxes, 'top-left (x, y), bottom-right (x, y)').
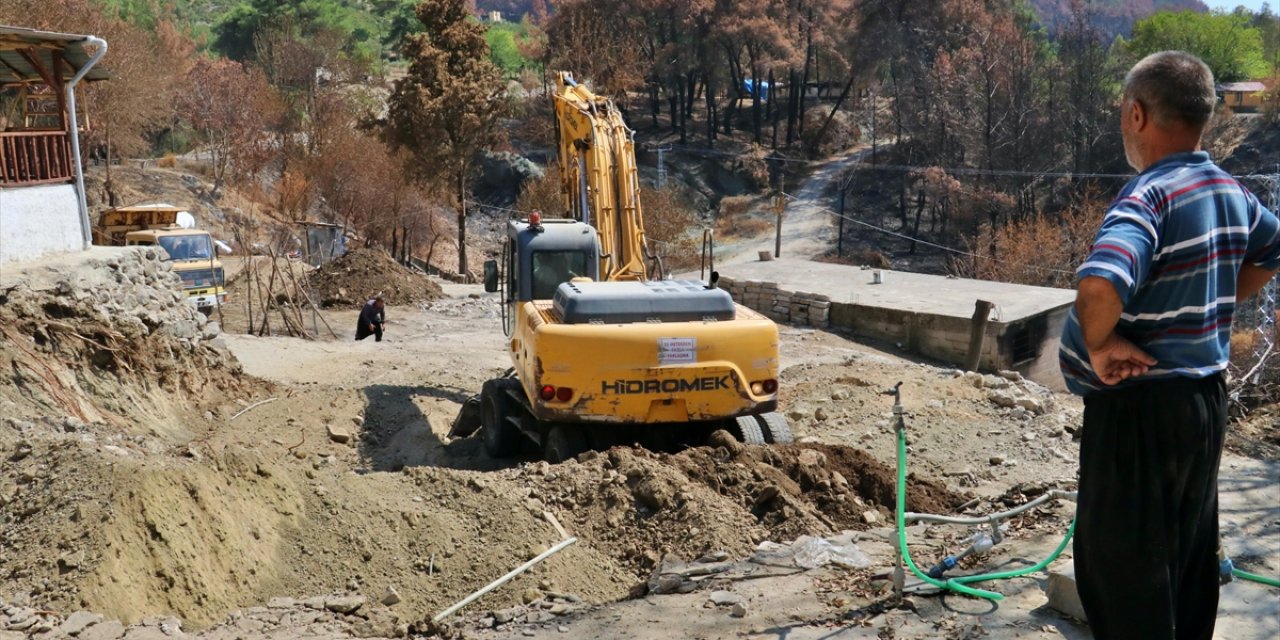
top-left (0, 184), bottom-right (84, 264)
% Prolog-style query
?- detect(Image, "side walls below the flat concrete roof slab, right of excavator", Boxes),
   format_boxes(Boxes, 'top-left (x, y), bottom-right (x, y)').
top-left (721, 272), bottom-right (1069, 390)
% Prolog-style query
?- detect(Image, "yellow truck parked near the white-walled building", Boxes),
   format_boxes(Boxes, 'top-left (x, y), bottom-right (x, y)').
top-left (93, 205), bottom-right (227, 315)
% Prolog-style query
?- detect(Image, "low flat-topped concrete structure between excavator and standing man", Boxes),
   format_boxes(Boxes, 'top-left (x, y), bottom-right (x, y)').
top-left (719, 259), bottom-right (1075, 389)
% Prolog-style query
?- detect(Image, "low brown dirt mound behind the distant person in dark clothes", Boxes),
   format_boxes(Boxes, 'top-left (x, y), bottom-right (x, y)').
top-left (311, 248), bottom-right (443, 307)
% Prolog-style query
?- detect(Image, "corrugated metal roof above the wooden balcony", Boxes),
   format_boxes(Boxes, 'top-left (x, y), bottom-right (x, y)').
top-left (0, 24), bottom-right (111, 84)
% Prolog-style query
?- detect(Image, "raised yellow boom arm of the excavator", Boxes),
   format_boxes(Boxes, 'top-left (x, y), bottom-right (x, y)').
top-left (553, 72), bottom-right (649, 280)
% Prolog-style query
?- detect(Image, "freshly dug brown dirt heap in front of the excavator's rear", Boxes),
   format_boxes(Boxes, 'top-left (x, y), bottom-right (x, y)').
top-left (517, 431), bottom-right (965, 577)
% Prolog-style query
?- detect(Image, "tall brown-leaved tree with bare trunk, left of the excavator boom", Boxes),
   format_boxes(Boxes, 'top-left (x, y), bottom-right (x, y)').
top-left (387, 0), bottom-right (507, 279)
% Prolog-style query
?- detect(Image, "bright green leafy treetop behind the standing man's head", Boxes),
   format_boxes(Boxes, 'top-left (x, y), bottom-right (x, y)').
top-left (1126, 12), bottom-right (1268, 82)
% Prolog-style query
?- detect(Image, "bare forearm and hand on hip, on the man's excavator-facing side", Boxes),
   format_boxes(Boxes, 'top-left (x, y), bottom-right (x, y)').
top-left (1075, 275), bottom-right (1156, 385)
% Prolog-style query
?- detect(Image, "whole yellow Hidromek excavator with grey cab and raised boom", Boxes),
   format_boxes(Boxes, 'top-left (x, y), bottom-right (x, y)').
top-left (451, 72), bottom-right (792, 462)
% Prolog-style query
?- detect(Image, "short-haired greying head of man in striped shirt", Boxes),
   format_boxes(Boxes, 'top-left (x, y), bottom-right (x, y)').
top-left (1124, 51), bottom-right (1217, 133)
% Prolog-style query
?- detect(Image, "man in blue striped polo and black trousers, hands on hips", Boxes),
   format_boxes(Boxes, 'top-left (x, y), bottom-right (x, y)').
top-left (1060, 51), bottom-right (1280, 640)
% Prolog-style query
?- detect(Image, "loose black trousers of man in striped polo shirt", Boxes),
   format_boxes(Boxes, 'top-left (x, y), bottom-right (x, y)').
top-left (1074, 375), bottom-right (1226, 640)
